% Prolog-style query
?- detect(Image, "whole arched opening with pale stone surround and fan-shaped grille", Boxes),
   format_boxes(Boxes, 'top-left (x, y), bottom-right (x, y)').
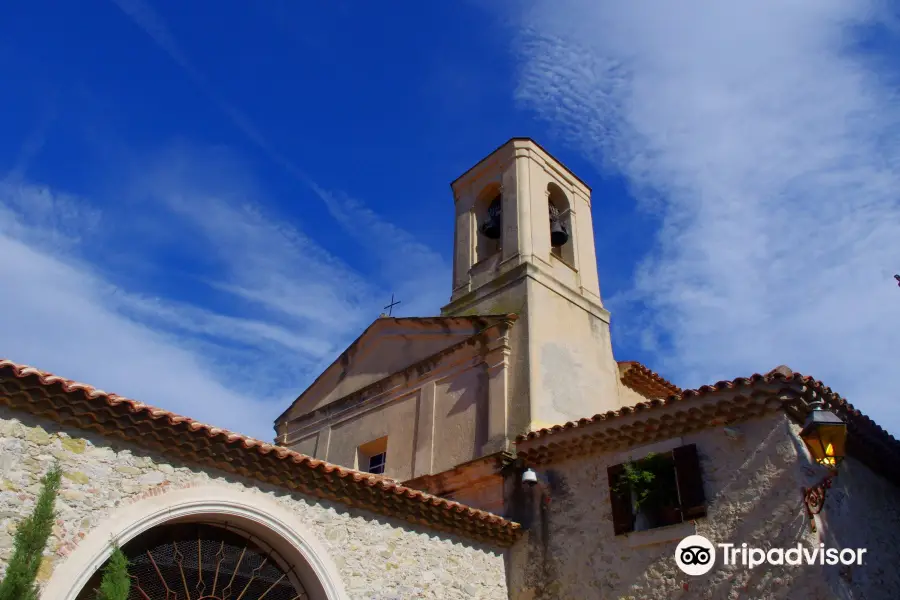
top-left (41, 484), bottom-right (347, 600)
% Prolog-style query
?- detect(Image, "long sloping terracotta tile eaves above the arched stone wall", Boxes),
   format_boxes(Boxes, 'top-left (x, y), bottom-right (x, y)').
top-left (0, 359), bottom-right (520, 546)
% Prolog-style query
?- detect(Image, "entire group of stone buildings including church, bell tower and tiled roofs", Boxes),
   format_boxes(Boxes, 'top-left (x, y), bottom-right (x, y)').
top-left (0, 138), bottom-right (900, 600)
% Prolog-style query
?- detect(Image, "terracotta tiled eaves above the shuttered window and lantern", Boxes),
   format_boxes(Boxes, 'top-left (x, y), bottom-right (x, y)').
top-left (516, 366), bottom-right (900, 484)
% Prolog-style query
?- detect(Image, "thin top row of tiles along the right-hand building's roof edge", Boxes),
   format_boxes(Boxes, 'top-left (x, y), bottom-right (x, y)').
top-left (516, 363), bottom-right (900, 451)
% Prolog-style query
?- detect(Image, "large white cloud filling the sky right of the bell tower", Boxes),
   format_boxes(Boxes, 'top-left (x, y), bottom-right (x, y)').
top-left (510, 0), bottom-right (900, 432)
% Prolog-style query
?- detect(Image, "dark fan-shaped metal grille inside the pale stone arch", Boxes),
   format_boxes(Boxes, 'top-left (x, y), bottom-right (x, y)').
top-left (79, 524), bottom-right (307, 600)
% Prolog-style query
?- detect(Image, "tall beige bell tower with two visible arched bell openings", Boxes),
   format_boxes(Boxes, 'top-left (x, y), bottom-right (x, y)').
top-left (441, 138), bottom-right (620, 436)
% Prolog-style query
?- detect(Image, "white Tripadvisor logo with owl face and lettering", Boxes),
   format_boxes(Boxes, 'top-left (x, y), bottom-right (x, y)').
top-left (675, 535), bottom-right (867, 576)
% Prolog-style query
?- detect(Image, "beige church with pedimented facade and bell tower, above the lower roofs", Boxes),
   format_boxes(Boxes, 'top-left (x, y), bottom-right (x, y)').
top-left (275, 138), bottom-right (640, 513)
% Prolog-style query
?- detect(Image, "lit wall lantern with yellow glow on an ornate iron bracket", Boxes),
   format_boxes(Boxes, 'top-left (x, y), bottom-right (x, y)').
top-left (800, 400), bottom-right (847, 531)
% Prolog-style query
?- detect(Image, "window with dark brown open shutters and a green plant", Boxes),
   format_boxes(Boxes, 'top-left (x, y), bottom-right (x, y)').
top-left (607, 444), bottom-right (706, 535)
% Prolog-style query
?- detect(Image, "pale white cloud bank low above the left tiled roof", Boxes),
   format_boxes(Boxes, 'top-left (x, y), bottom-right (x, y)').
top-left (0, 189), bottom-right (282, 439)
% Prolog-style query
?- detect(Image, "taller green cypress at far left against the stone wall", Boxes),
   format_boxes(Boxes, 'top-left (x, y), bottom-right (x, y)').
top-left (0, 464), bottom-right (62, 600)
